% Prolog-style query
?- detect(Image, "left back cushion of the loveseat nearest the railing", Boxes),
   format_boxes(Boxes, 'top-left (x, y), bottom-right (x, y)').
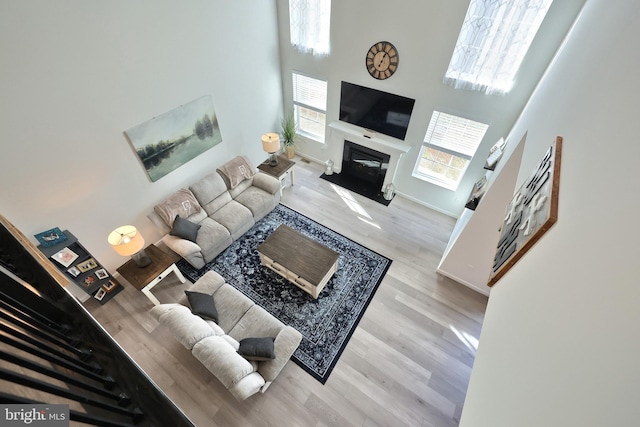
top-left (151, 304), bottom-right (214, 350)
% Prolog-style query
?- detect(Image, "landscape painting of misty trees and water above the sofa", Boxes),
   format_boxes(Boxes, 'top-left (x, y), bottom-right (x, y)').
top-left (125, 95), bottom-right (222, 182)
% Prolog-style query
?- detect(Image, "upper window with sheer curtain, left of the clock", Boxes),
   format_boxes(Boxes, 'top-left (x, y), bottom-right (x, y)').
top-left (289, 0), bottom-right (331, 56)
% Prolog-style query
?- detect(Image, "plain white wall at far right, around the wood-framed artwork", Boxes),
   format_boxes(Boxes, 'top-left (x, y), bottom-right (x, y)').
top-left (460, 0), bottom-right (640, 427)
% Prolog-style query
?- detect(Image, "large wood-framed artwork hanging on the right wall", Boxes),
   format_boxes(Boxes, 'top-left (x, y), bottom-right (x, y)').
top-left (488, 136), bottom-right (562, 286)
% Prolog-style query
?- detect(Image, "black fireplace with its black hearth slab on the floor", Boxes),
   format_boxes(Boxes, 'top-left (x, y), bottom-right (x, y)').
top-left (321, 140), bottom-right (391, 205)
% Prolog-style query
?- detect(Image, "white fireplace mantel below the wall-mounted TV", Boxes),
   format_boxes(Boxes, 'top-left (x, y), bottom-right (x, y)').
top-left (329, 121), bottom-right (411, 188)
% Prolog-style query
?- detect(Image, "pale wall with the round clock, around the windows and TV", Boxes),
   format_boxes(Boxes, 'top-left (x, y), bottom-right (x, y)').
top-left (277, 0), bottom-right (585, 216)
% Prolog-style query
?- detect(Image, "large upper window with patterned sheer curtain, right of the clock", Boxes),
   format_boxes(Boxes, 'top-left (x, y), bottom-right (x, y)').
top-left (444, 0), bottom-right (553, 94)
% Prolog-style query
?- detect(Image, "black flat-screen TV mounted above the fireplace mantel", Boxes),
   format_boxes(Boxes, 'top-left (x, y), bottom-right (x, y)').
top-left (340, 82), bottom-right (415, 140)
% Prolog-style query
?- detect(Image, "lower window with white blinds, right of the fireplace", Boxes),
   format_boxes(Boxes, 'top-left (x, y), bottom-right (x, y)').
top-left (413, 111), bottom-right (489, 190)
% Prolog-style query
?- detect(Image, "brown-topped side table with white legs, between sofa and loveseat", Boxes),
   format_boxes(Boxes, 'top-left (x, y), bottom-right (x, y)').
top-left (116, 243), bottom-right (186, 305)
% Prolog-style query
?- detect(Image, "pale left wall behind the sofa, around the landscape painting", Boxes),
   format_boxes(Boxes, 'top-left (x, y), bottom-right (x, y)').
top-left (0, 0), bottom-right (282, 271)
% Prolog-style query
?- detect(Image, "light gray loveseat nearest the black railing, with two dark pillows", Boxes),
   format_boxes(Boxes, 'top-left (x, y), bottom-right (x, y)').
top-left (151, 271), bottom-right (302, 400)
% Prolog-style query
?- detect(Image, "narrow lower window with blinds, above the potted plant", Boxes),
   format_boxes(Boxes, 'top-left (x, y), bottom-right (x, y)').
top-left (293, 72), bottom-right (327, 143)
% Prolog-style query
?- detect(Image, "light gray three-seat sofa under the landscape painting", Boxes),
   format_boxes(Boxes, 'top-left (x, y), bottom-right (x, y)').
top-left (148, 156), bottom-right (281, 269)
